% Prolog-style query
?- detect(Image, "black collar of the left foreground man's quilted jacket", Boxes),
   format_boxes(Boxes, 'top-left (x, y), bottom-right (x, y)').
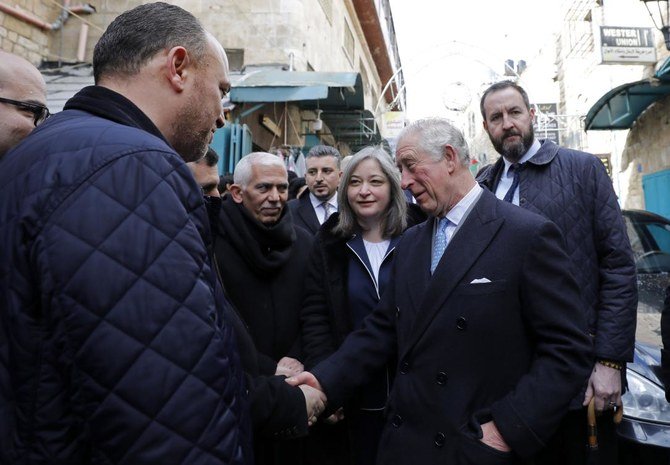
top-left (63, 86), bottom-right (170, 145)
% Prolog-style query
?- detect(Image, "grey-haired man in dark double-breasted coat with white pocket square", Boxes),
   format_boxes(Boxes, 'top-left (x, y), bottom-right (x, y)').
top-left (290, 119), bottom-right (592, 465)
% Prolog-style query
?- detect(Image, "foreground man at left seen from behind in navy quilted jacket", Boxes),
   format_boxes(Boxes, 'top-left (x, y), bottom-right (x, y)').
top-left (0, 3), bottom-right (253, 465)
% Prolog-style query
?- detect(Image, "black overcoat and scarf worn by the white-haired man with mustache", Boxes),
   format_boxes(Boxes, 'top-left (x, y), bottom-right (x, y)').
top-left (215, 196), bottom-right (313, 375)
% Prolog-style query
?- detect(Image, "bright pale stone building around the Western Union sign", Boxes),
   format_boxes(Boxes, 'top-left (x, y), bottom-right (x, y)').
top-left (467, 0), bottom-right (670, 209)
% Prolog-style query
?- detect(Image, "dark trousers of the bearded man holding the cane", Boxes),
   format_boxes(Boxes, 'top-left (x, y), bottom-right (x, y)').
top-left (531, 407), bottom-right (619, 465)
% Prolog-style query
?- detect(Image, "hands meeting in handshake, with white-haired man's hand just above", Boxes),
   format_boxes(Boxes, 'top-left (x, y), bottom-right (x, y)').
top-left (276, 357), bottom-right (334, 426)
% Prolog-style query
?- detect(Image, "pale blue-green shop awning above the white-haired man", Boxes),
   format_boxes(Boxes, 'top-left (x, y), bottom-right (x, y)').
top-left (230, 69), bottom-right (364, 110)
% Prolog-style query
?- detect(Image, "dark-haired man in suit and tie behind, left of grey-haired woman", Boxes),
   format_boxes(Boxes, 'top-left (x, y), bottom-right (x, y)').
top-left (287, 145), bottom-right (342, 234)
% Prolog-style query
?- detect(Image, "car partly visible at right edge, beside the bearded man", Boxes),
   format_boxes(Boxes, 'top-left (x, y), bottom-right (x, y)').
top-left (617, 210), bottom-right (670, 465)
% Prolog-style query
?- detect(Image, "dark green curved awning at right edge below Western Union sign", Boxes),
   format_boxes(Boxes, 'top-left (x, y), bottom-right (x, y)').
top-left (584, 58), bottom-right (670, 131)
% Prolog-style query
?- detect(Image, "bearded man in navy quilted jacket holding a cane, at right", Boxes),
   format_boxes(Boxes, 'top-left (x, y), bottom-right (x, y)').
top-left (477, 81), bottom-right (637, 464)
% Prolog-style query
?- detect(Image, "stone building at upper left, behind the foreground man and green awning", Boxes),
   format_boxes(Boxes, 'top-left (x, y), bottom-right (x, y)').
top-left (0, 0), bottom-right (403, 156)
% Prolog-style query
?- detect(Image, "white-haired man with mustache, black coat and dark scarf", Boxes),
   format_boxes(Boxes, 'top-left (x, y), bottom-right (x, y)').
top-left (214, 152), bottom-right (313, 465)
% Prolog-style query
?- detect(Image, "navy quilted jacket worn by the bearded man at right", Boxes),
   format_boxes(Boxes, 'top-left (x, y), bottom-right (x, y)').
top-left (477, 140), bottom-right (637, 361)
